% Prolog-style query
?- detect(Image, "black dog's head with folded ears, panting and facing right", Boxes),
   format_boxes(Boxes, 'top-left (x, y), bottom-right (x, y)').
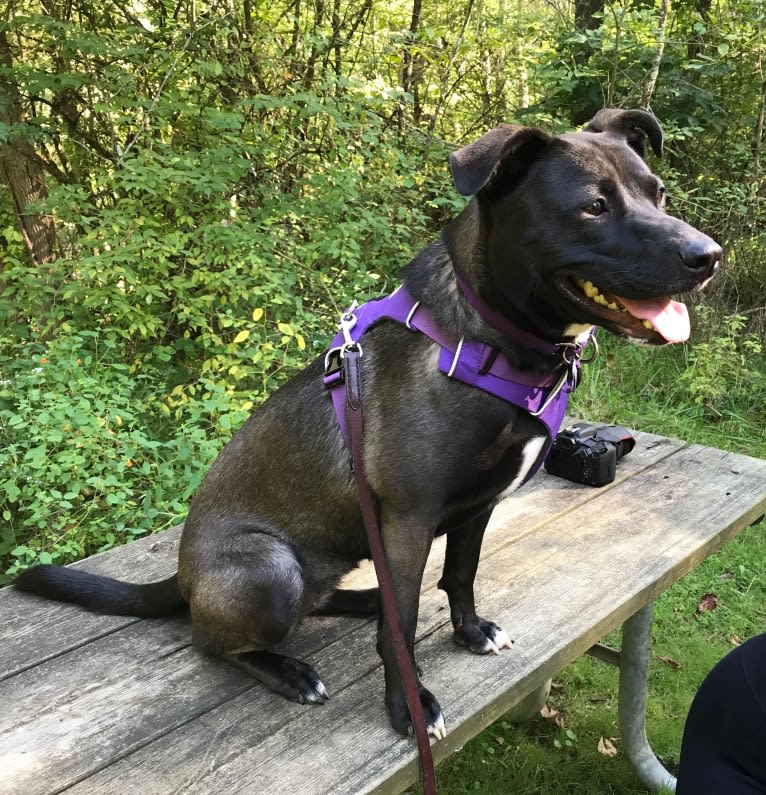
top-left (450, 110), bottom-right (722, 344)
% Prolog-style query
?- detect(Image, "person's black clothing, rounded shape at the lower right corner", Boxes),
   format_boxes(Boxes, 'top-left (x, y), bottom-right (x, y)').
top-left (676, 633), bottom-right (766, 795)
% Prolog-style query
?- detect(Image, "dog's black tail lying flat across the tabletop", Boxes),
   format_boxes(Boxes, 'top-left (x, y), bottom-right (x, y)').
top-left (13, 565), bottom-right (187, 618)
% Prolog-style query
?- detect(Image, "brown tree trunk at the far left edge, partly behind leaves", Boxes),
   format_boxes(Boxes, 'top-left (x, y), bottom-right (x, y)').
top-left (0, 29), bottom-right (58, 265)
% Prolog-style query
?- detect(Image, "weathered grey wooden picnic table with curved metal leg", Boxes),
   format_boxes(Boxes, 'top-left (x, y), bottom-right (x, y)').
top-left (0, 434), bottom-right (766, 795)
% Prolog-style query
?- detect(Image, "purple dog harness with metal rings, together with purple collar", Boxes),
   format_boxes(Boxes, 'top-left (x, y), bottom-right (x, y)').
top-left (324, 284), bottom-right (595, 483)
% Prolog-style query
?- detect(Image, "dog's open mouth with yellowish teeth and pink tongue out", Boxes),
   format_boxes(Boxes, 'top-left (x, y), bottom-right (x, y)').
top-left (559, 276), bottom-right (691, 345)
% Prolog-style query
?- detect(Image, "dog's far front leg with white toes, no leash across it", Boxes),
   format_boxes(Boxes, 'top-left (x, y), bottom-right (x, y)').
top-left (438, 512), bottom-right (512, 654)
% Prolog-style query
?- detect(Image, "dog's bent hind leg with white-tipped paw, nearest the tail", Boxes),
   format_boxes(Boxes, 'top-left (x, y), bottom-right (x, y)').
top-left (189, 531), bottom-right (328, 704)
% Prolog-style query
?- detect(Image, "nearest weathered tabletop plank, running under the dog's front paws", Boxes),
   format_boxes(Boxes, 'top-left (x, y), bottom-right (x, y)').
top-left (49, 447), bottom-right (766, 793)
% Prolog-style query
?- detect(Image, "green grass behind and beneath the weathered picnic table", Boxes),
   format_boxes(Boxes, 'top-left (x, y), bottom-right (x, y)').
top-left (428, 335), bottom-right (766, 795)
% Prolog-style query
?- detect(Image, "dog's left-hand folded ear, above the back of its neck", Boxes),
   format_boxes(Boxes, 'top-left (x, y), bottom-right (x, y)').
top-left (450, 124), bottom-right (553, 196)
